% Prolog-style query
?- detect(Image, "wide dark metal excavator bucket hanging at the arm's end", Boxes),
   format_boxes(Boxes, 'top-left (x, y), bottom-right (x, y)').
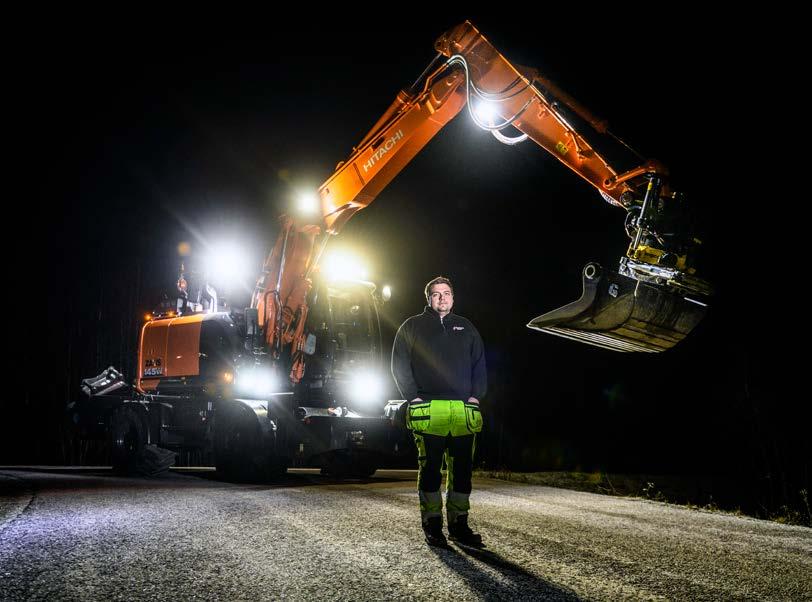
top-left (527, 263), bottom-right (707, 353)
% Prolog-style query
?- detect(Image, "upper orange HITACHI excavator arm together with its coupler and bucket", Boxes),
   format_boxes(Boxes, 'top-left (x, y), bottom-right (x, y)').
top-left (254, 21), bottom-right (711, 370)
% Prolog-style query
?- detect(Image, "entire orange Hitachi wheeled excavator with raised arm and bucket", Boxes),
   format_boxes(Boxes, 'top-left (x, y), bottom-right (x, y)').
top-left (72, 22), bottom-right (712, 476)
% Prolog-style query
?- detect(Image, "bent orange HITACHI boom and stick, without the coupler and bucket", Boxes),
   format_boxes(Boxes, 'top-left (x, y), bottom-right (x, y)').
top-left (319, 21), bottom-right (668, 234)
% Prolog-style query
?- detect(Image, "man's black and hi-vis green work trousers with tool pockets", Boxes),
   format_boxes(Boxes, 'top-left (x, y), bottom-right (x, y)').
top-left (406, 399), bottom-right (482, 525)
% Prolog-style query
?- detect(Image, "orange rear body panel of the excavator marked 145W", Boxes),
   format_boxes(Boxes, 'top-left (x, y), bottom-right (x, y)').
top-left (138, 314), bottom-right (207, 391)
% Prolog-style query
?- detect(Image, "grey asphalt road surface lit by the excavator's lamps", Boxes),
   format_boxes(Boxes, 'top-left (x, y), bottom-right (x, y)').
top-left (0, 469), bottom-right (812, 601)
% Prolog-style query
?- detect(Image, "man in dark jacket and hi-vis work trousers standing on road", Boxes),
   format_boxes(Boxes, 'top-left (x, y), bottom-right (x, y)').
top-left (392, 276), bottom-right (487, 547)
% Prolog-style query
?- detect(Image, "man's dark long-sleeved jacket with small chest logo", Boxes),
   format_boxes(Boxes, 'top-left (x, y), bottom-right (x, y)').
top-left (392, 306), bottom-right (488, 401)
